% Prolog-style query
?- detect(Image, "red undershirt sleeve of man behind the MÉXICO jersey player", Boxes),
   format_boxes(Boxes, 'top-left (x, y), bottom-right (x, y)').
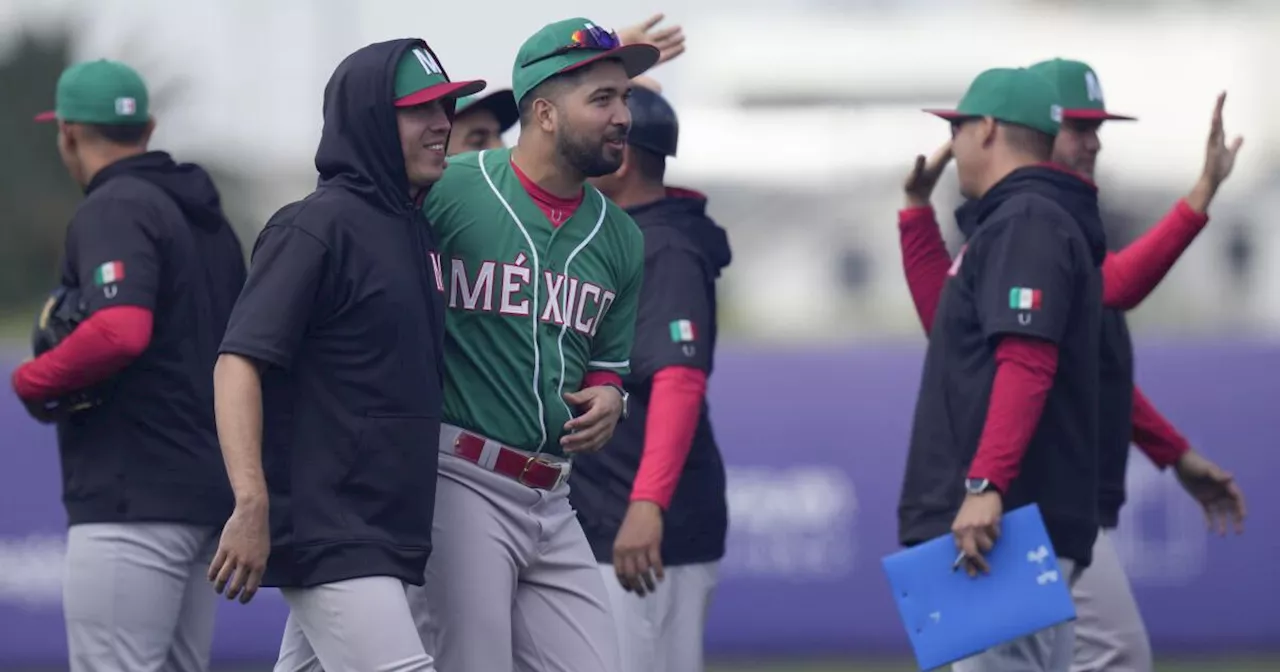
top-left (631, 366), bottom-right (707, 511)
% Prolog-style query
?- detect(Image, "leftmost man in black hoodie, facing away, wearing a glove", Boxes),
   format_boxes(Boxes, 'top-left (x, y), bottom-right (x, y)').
top-left (13, 60), bottom-right (244, 672)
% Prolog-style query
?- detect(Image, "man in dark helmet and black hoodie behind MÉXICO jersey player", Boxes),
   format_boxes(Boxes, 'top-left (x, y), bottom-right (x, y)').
top-left (570, 86), bottom-right (731, 672)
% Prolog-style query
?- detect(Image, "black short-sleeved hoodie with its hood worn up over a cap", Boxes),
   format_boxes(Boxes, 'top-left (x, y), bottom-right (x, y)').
top-left (221, 40), bottom-right (444, 586)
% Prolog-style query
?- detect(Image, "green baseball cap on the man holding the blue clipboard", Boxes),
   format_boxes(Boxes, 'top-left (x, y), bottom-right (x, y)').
top-left (924, 68), bottom-right (1062, 136)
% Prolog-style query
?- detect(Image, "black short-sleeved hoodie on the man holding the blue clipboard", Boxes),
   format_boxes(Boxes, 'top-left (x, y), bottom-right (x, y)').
top-left (899, 166), bottom-right (1106, 567)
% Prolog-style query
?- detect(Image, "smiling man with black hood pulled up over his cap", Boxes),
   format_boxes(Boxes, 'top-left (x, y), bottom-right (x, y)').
top-left (209, 40), bottom-right (484, 672)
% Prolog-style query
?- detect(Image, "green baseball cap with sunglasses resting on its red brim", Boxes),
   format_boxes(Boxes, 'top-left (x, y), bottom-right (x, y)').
top-left (511, 18), bottom-right (659, 104)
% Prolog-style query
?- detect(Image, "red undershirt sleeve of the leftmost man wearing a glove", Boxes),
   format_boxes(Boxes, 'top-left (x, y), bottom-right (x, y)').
top-left (13, 306), bottom-right (152, 401)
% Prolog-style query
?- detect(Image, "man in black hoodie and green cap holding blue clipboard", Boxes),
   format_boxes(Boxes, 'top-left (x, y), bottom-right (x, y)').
top-left (899, 68), bottom-right (1106, 672)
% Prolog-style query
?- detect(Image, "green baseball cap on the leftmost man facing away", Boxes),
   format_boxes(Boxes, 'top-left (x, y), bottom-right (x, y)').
top-left (36, 59), bottom-right (151, 125)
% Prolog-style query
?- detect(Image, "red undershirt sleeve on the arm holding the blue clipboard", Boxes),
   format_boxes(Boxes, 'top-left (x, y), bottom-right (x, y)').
top-left (969, 335), bottom-right (1057, 493)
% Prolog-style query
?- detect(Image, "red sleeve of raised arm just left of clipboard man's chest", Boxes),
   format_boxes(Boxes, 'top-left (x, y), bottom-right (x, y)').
top-left (897, 207), bottom-right (951, 334)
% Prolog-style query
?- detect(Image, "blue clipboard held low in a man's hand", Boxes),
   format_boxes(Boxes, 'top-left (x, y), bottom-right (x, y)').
top-left (881, 504), bottom-right (1075, 669)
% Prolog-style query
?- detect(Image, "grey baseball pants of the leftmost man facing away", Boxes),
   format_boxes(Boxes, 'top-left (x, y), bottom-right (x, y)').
top-left (63, 522), bottom-right (218, 672)
